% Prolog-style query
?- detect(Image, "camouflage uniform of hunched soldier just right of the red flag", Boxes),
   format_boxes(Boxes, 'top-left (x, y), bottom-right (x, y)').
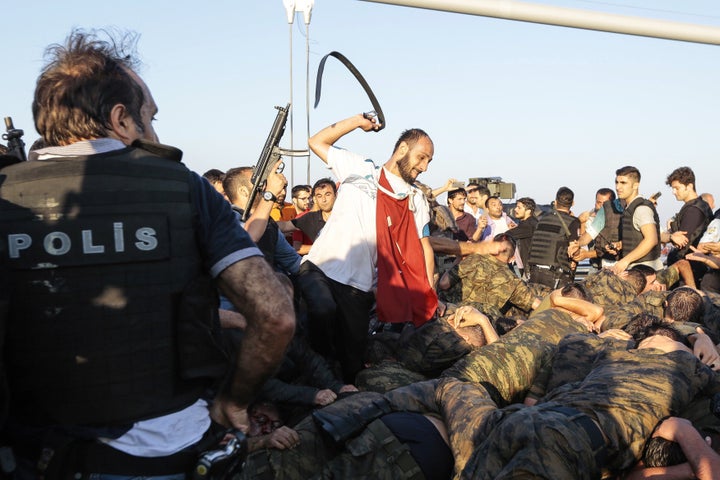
top-left (441, 254), bottom-right (535, 314)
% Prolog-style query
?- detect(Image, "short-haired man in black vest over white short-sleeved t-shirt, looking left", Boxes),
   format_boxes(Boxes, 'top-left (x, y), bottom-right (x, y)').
top-left (612, 166), bottom-right (663, 273)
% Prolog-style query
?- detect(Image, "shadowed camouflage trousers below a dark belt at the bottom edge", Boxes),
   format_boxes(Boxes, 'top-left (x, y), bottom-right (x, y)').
top-left (461, 404), bottom-right (605, 480)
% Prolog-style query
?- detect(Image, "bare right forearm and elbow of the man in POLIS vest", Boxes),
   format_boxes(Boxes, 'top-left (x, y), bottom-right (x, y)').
top-left (213, 257), bottom-right (295, 428)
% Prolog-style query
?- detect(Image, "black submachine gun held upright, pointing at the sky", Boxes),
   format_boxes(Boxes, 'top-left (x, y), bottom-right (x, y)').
top-left (242, 103), bottom-right (310, 222)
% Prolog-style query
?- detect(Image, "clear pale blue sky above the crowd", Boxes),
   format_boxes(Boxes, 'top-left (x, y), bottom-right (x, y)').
top-left (0, 0), bottom-right (720, 225)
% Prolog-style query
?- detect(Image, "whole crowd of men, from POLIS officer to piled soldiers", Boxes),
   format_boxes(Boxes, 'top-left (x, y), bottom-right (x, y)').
top-left (0, 30), bottom-right (720, 480)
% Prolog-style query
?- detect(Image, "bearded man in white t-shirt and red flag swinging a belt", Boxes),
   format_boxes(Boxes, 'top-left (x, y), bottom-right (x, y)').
top-left (301, 114), bottom-right (437, 383)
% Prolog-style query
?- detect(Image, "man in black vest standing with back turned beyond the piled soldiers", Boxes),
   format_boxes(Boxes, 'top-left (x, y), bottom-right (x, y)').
top-left (528, 187), bottom-right (580, 288)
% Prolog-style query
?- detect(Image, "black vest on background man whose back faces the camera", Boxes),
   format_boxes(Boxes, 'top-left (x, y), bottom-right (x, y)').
top-left (528, 210), bottom-right (576, 272)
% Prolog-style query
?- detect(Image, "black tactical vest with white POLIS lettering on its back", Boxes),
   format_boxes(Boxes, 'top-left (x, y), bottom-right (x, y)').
top-left (0, 148), bottom-right (227, 426)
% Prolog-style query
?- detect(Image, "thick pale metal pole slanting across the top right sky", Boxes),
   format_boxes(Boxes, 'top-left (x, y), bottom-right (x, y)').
top-left (363, 0), bottom-right (720, 45)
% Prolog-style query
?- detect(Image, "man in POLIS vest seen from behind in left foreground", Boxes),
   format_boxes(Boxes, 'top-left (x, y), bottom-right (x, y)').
top-left (0, 30), bottom-right (295, 479)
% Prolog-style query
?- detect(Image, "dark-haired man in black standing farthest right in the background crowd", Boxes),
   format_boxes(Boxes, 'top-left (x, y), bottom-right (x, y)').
top-left (660, 167), bottom-right (713, 284)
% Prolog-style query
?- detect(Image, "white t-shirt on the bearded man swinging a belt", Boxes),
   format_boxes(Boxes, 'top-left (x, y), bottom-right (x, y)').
top-left (303, 147), bottom-right (430, 292)
